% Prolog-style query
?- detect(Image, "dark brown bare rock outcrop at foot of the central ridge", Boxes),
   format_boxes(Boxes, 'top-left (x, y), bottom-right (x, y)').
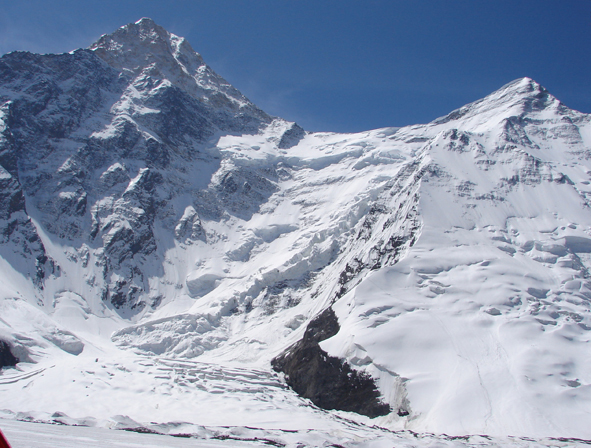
top-left (272, 308), bottom-right (391, 417)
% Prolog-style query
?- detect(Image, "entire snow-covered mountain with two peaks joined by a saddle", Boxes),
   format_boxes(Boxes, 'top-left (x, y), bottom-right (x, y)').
top-left (0, 19), bottom-right (591, 446)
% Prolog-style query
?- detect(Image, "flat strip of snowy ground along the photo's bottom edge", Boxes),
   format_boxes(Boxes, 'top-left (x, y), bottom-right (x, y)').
top-left (0, 418), bottom-right (591, 448)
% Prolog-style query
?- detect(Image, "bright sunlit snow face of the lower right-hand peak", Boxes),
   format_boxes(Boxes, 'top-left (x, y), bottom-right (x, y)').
top-left (321, 79), bottom-right (591, 437)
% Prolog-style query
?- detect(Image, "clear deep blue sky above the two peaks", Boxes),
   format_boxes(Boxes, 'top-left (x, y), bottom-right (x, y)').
top-left (0, 0), bottom-right (591, 132)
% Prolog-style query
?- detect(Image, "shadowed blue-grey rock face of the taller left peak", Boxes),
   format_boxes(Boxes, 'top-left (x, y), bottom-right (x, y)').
top-left (0, 19), bottom-right (275, 314)
